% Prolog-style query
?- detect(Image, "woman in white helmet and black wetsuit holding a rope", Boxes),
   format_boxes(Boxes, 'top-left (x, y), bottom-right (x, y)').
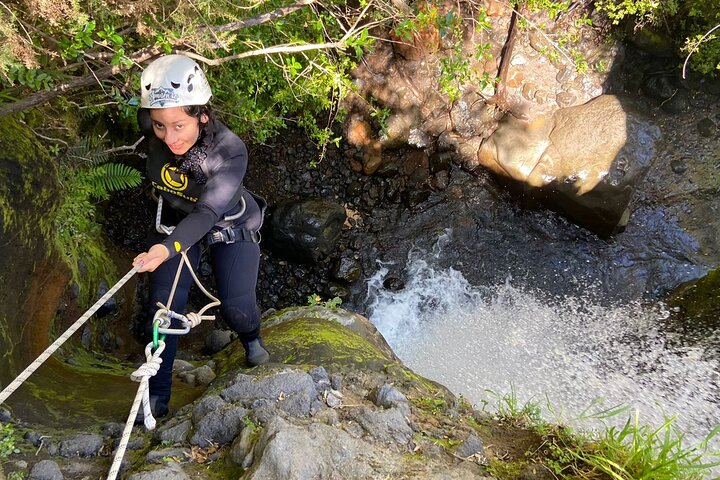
top-left (133, 55), bottom-right (270, 417)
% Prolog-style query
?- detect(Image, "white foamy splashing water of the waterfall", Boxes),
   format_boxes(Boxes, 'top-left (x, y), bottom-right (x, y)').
top-left (368, 240), bottom-right (720, 464)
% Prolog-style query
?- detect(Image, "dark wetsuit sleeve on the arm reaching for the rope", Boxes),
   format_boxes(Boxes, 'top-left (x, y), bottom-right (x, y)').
top-left (162, 146), bottom-right (247, 258)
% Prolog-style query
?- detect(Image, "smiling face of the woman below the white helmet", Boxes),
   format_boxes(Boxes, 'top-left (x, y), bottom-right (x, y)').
top-left (150, 107), bottom-right (208, 155)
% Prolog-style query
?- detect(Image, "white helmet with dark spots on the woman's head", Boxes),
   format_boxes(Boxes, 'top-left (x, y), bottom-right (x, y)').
top-left (140, 55), bottom-right (212, 108)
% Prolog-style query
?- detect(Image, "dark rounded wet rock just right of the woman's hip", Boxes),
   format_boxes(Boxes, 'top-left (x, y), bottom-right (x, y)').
top-left (269, 198), bottom-right (345, 263)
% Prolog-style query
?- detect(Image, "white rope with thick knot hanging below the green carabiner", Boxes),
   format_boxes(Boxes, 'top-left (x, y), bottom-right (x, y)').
top-left (107, 340), bottom-right (165, 480)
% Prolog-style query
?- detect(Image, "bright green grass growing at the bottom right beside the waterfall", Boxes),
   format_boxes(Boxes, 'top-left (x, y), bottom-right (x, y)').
top-left (489, 390), bottom-right (720, 480)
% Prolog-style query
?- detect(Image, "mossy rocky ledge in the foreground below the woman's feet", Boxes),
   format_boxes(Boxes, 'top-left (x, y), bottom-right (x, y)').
top-left (0, 307), bottom-right (560, 480)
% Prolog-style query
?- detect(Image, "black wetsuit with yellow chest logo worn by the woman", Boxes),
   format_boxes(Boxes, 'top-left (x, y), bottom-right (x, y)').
top-left (140, 120), bottom-right (265, 403)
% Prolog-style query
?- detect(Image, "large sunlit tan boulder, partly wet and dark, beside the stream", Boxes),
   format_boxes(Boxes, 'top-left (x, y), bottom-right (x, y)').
top-left (477, 95), bottom-right (660, 235)
